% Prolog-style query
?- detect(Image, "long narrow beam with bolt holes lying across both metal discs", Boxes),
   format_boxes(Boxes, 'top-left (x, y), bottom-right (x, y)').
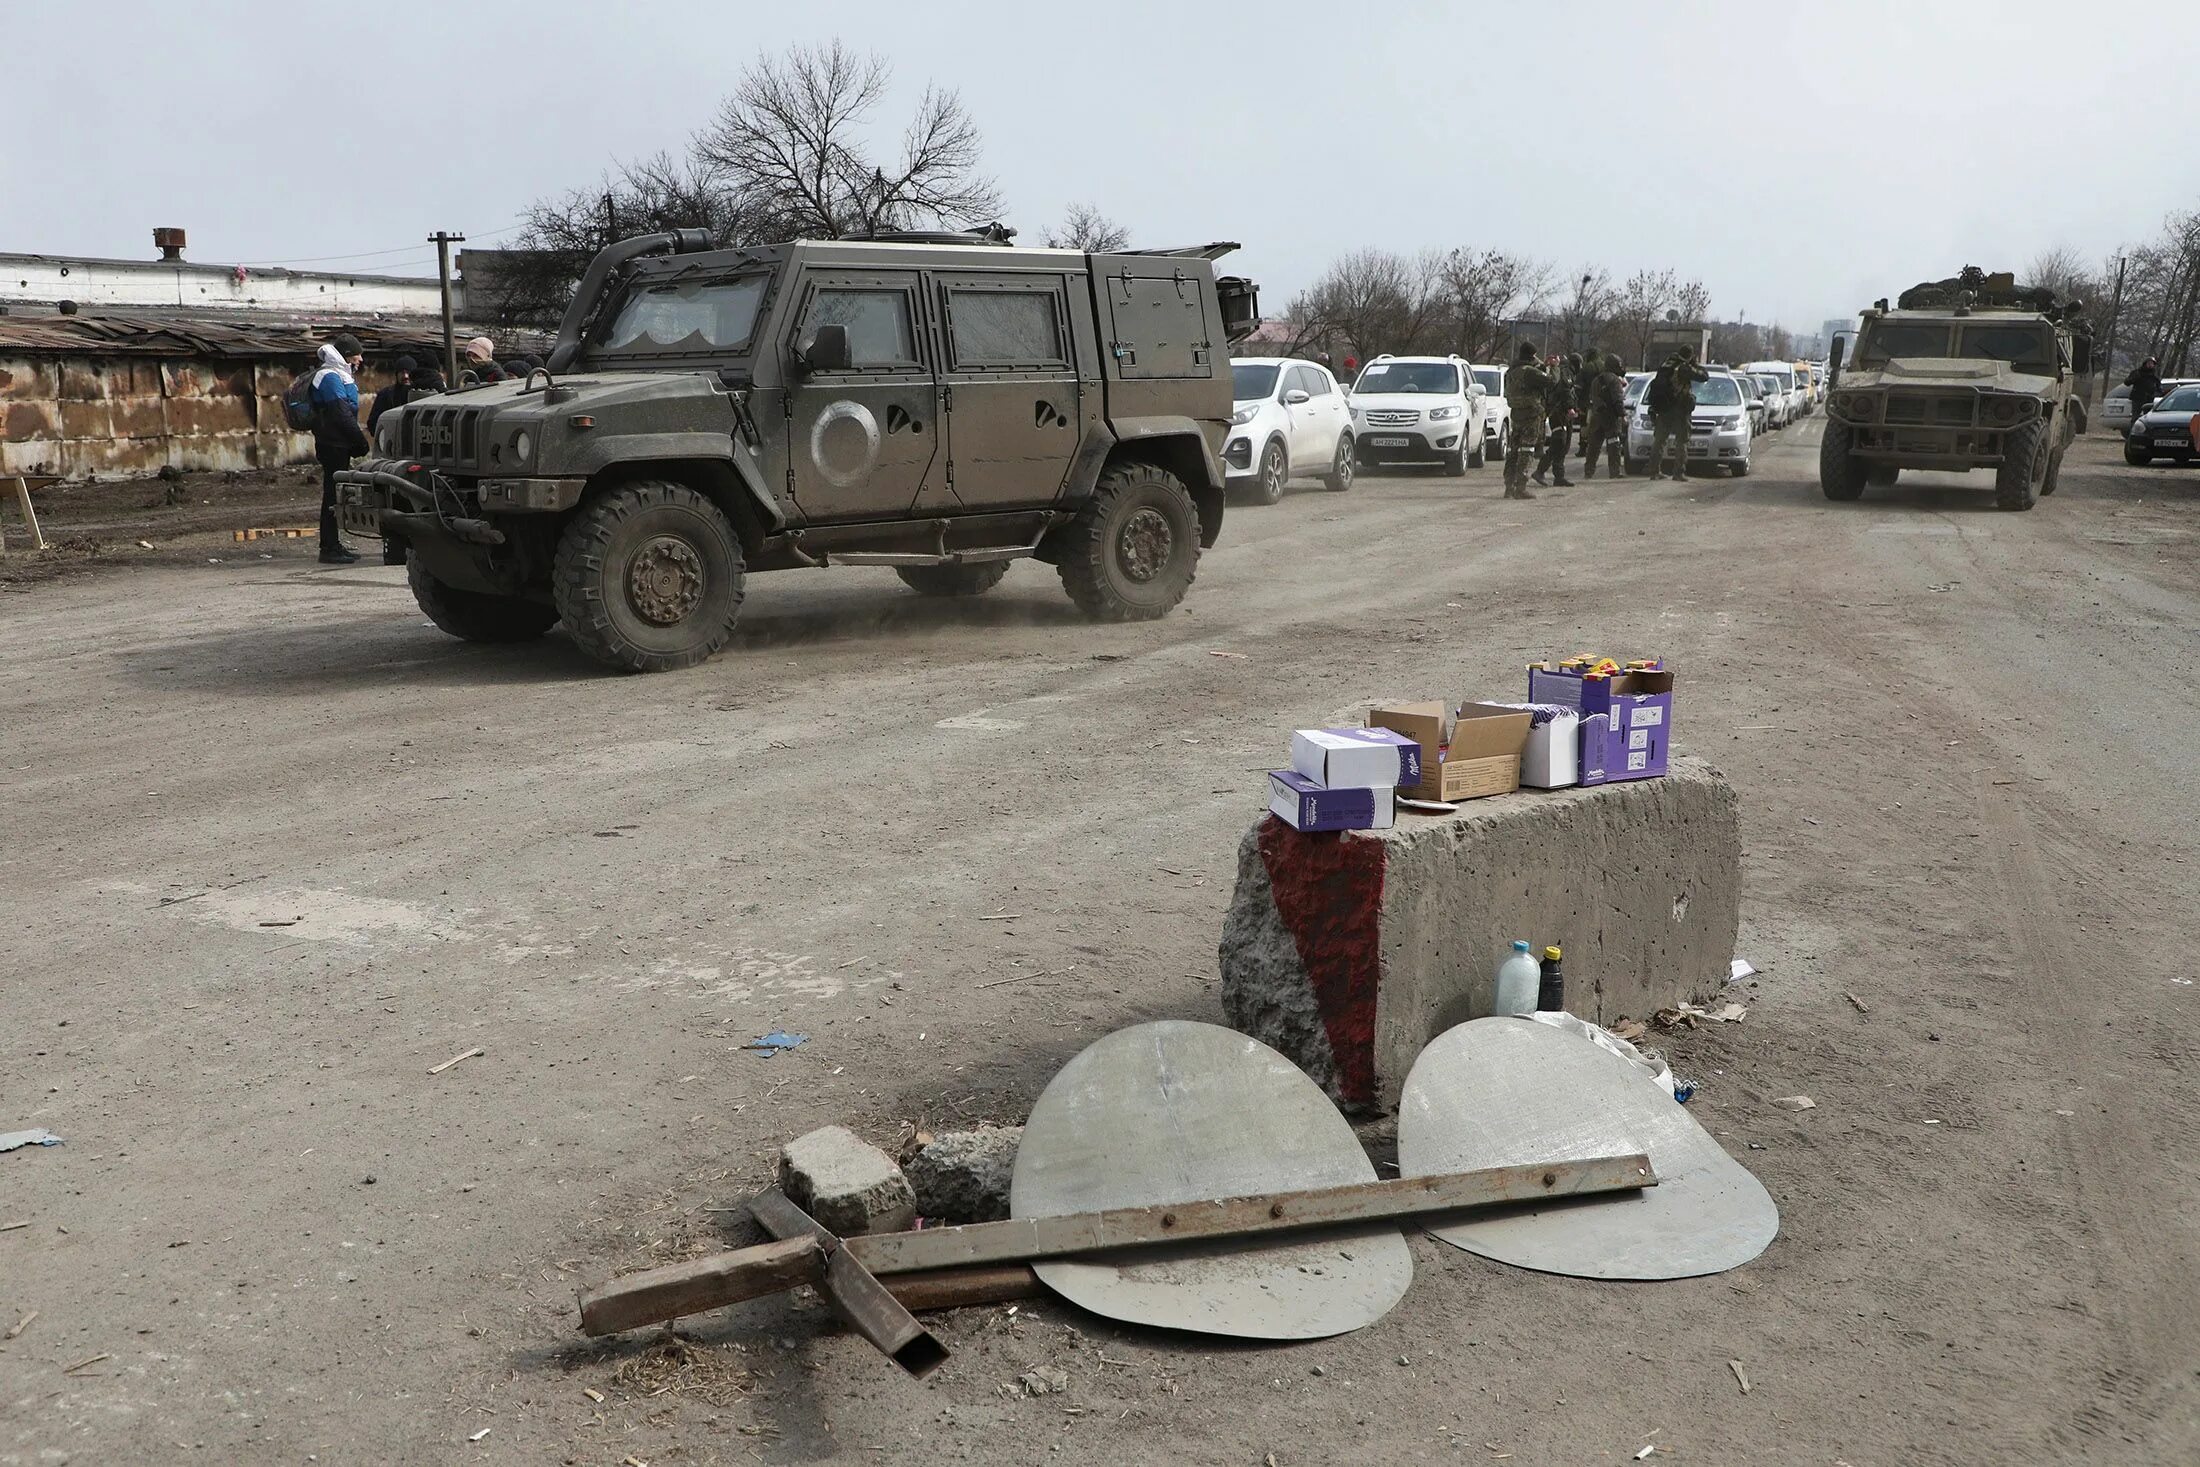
top-left (843, 1152), bottom-right (1657, 1278)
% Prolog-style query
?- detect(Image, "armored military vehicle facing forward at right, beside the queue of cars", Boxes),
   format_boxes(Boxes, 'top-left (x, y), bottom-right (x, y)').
top-left (1817, 266), bottom-right (2092, 510)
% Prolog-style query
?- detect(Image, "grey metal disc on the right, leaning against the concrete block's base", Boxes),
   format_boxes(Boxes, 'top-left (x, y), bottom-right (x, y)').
top-left (1397, 1018), bottom-right (1780, 1278)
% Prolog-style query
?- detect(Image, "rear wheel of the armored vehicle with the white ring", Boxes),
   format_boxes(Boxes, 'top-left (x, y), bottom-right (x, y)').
top-left (1056, 460), bottom-right (1199, 622)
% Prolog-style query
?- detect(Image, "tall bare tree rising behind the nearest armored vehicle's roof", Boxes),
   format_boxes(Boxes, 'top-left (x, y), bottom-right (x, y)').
top-left (695, 40), bottom-right (1001, 240)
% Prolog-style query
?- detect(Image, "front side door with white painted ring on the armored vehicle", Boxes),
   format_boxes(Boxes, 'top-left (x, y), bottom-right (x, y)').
top-left (783, 271), bottom-right (946, 521)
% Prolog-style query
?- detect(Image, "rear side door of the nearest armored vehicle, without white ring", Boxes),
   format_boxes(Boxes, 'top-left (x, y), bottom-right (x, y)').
top-left (935, 271), bottom-right (1085, 510)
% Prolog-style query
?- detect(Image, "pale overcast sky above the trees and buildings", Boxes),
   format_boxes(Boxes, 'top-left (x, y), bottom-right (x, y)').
top-left (0, 0), bottom-right (2200, 332)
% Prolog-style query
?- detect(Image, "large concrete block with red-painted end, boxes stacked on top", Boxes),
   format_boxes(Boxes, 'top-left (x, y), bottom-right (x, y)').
top-left (1221, 759), bottom-right (1742, 1111)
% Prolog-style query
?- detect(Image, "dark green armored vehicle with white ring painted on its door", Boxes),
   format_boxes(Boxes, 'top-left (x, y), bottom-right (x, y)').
top-left (339, 229), bottom-right (1256, 671)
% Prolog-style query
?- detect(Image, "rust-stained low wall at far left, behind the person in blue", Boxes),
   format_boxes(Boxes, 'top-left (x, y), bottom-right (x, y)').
top-left (0, 354), bottom-right (387, 479)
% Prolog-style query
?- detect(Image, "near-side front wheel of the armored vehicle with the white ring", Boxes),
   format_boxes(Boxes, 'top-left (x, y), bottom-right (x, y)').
top-left (550, 479), bottom-right (746, 673)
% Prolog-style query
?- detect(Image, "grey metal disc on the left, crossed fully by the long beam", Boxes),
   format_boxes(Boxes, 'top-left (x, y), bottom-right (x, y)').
top-left (1008, 1018), bottom-right (1412, 1339)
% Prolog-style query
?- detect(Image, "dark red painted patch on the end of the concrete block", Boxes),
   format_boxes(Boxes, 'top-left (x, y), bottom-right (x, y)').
top-left (1258, 816), bottom-right (1384, 1104)
